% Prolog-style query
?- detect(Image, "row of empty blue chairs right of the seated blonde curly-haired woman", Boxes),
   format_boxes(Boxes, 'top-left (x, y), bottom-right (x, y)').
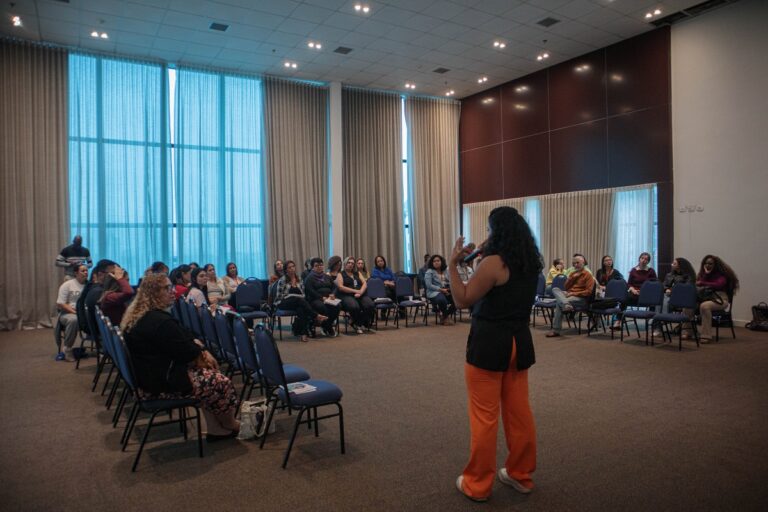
top-left (172, 300), bottom-right (345, 468)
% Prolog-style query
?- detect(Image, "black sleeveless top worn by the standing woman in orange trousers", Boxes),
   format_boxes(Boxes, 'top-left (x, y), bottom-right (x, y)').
top-left (467, 274), bottom-right (538, 372)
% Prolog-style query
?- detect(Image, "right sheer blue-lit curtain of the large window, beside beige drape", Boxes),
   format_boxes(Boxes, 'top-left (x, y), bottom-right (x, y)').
top-left (173, 68), bottom-right (266, 277)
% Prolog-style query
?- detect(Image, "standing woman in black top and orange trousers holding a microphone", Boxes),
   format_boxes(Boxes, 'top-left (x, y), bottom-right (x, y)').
top-left (449, 206), bottom-right (543, 501)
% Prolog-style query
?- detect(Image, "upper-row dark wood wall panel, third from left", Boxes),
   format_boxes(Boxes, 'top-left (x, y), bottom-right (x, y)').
top-left (549, 50), bottom-right (605, 130)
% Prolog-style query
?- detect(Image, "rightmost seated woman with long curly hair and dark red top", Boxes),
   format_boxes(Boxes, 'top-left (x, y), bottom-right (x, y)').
top-left (696, 254), bottom-right (739, 343)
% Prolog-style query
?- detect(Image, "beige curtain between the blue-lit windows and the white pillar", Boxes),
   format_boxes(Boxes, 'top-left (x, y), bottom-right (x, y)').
top-left (264, 78), bottom-right (329, 271)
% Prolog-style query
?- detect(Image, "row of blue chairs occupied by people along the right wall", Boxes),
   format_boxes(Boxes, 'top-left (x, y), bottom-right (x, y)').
top-left (533, 275), bottom-right (736, 350)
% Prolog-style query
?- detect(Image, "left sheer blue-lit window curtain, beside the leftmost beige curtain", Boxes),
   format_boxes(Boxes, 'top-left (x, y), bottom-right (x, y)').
top-left (69, 54), bottom-right (169, 282)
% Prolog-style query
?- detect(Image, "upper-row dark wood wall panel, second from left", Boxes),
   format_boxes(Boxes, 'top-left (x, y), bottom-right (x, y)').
top-left (501, 70), bottom-right (549, 140)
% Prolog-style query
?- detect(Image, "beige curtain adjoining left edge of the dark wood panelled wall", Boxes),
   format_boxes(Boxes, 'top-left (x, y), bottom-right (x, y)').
top-left (405, 97), bottom-right (460, 269)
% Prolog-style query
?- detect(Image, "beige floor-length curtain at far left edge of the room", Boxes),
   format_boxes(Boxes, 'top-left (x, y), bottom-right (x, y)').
top-left (0, 40), bottom-right (69, 330)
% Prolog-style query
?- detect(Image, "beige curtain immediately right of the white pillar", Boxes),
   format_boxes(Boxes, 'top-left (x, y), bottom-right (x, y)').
top-left (341, 88), bottom-right (403, 271)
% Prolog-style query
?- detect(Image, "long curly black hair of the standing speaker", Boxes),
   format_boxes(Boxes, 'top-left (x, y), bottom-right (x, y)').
top-left (483, 206), bottom-right (544, 275)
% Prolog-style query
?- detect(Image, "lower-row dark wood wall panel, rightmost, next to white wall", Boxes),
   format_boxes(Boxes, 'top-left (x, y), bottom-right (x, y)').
top-left (608, 105), bottom-right (672, 187)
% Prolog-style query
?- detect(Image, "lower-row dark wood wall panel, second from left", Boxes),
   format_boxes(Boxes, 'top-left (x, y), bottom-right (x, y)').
top-left (503, 133), bottom-right (549, 197)
